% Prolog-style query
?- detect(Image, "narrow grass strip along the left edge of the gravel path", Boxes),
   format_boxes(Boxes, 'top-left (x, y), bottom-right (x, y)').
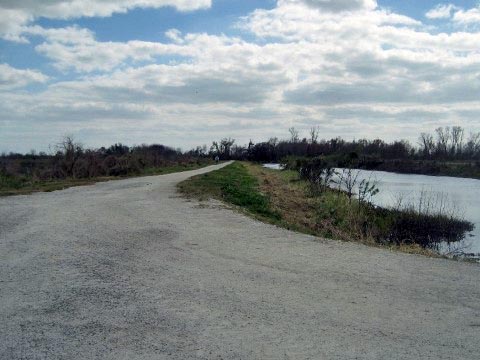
top-left (0, 160), bottom-right (213, 196)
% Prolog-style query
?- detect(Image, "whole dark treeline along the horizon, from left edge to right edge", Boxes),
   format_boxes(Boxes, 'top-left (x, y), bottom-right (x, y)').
top-left (0, 126), bottom-right (480, 180)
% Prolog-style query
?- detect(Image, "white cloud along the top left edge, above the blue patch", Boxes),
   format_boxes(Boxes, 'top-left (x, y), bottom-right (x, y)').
top-left (0, 0), bottom-right (212, 42)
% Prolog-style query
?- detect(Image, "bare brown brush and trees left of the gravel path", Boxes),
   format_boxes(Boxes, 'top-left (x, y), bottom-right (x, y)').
top-left (0, 137), bottom-right (209, 185)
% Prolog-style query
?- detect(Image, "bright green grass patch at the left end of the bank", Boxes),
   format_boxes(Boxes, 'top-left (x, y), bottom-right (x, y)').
top-left (178, 162), bottom-right (281, 222)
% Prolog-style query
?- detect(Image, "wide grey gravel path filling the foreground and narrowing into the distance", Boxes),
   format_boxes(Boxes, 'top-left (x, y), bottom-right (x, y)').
top-left (0, 165), bottom-right (480, 360)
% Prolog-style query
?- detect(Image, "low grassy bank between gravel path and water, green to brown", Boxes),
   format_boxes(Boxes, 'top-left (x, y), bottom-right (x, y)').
top-left (179, 162), bottom-right (470, 256)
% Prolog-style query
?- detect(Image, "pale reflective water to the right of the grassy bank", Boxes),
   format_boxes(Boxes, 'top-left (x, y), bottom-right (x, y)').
top-left (266, 164), bottom-right (480, 253)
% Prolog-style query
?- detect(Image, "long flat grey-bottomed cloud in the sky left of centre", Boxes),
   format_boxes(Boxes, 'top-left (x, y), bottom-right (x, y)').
top-left (68, 63), bottom-right (286, 106)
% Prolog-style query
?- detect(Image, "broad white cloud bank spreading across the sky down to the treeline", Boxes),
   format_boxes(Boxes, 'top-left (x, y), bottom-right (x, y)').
top-left (0, 0), bottom-right (480, 151)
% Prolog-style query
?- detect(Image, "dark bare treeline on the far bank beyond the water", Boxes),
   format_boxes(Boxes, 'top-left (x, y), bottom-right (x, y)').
top-left (217, 126), bottom-right (480, 178)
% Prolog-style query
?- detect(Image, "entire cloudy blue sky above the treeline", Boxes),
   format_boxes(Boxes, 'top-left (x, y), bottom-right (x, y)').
top-left (0, 0), bottom-right (480, 152)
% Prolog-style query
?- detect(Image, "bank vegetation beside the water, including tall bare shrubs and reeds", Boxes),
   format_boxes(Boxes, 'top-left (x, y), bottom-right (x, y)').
top-left (179, 159), bottom-right (474, 256)
